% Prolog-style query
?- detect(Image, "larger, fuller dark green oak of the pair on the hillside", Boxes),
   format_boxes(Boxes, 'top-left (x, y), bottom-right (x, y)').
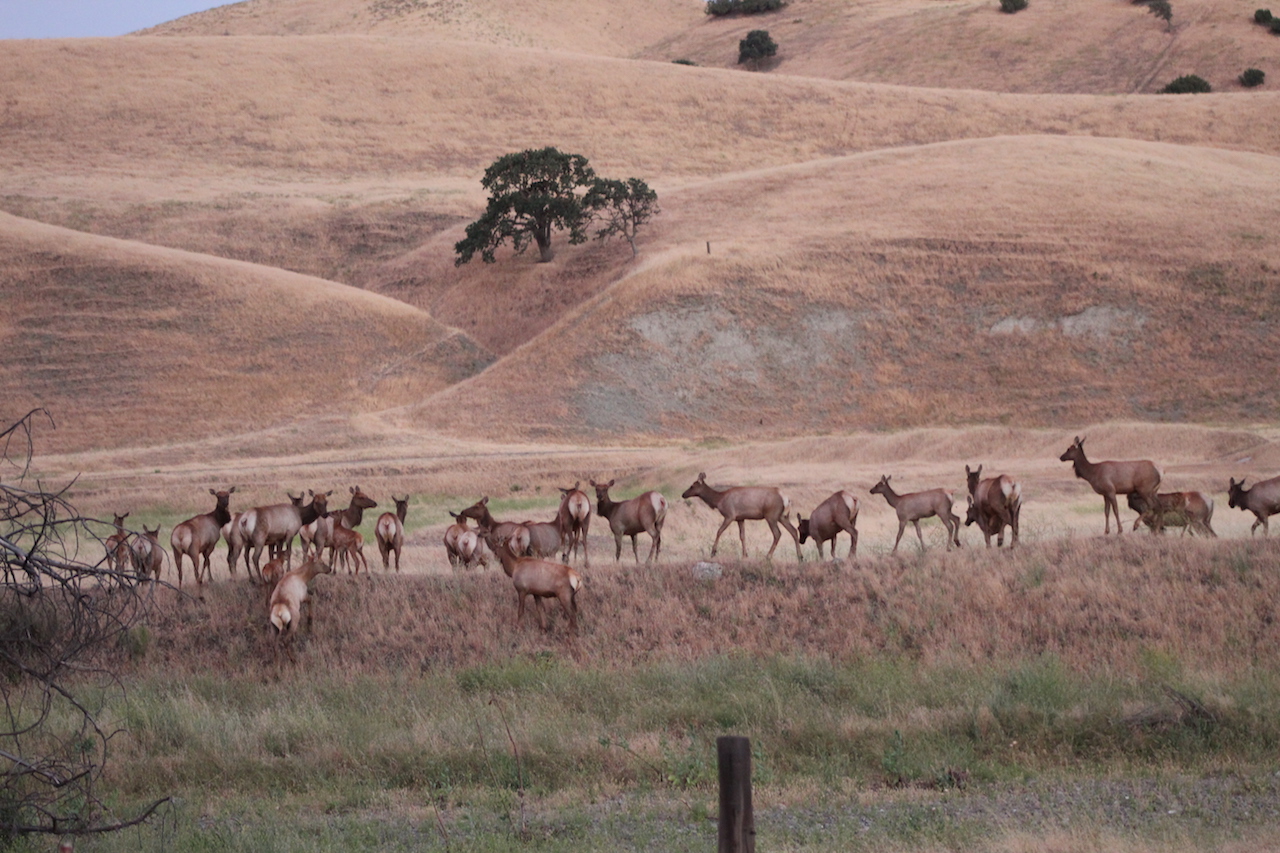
top-left (453, 147), bottom-right (595, 266)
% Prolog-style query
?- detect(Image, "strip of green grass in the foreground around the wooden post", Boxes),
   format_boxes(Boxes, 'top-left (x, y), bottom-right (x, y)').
top-left (67, 653), bottom-right (1280, 850)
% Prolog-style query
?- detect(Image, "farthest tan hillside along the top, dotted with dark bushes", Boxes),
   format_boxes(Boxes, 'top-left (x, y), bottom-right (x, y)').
top-left (142, 0), bottom-right (1280, 93)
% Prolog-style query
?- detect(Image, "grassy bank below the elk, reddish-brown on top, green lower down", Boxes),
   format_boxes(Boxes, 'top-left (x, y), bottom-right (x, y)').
top-left (70, 537), bottom-right (1280, 850)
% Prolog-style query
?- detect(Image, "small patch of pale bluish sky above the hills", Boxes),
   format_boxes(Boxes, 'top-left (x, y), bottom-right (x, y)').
top-left (0, 0), bottom-right (232, 38)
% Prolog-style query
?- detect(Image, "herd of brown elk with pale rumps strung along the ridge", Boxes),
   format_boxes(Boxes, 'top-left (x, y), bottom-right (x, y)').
top-left (104, 437), bottom-right (1280, 656)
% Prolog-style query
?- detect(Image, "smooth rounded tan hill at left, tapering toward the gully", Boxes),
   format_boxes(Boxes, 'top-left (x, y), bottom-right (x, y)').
top-left (0, 214), bottom-right (492, 452)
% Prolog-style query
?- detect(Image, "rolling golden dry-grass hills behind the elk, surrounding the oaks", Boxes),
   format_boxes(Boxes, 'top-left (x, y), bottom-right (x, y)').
top-left (0, 0), bottom-right (1280, 450)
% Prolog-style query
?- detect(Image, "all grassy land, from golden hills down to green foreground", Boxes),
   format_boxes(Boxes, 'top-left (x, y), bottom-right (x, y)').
top-left (0, 0), bottom-right (1280, 850)
